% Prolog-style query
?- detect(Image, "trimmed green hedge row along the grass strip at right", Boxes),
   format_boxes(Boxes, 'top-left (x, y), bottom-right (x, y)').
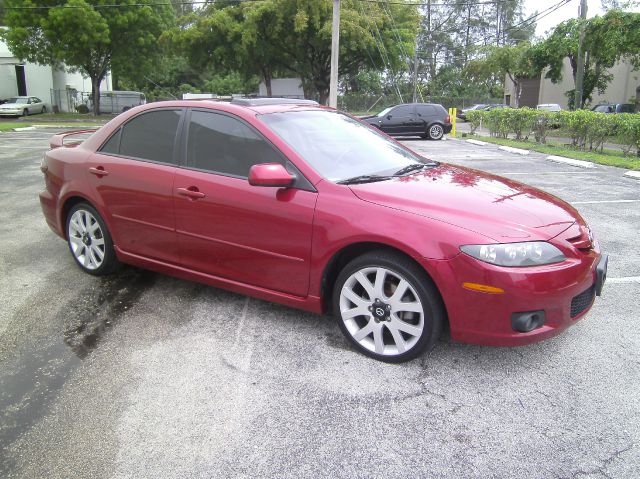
top-left (467, 107), bottom-right (640, 155)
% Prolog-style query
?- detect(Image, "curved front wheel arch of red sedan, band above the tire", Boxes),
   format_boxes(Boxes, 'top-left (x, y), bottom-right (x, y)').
top-left (320, 241), bottom-right (448, 322)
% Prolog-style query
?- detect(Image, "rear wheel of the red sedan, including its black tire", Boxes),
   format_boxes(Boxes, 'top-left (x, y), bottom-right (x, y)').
top-left (65, 202), bottom-right (120, 276)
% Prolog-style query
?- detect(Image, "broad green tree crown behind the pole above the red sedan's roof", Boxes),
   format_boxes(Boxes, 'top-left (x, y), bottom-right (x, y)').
top-left (165, 0), bottom-right (418, 103)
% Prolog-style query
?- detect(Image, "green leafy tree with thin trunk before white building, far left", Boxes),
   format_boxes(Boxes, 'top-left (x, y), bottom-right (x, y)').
top-left (0, 0), bottom-right (174, 115)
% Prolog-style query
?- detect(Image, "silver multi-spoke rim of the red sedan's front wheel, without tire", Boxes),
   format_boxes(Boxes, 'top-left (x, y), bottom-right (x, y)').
top-left (340, 267), bottom-right (424, 356)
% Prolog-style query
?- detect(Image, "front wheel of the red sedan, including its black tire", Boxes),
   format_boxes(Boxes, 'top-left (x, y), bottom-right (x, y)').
top-left (333, 250), bottom-right (445, 363)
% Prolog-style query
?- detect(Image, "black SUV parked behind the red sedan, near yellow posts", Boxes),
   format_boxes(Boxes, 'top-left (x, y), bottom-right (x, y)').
top-left (362, 103), bottom-right (452, 140)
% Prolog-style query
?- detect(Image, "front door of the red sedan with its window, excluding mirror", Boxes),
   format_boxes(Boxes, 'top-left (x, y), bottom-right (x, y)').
top-left (174, 110), bottom-right (317, 296)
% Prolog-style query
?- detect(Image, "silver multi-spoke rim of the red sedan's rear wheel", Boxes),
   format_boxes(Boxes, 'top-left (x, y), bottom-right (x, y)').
top-left (68, 210), bottom-right (105, 270)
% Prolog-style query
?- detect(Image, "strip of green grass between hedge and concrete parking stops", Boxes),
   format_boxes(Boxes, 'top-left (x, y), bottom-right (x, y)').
top-left (467, 135), bottom-right (640, 170)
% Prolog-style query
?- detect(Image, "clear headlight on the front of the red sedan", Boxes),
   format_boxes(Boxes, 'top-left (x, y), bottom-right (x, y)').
top-left (460, 241), bottom-right (566, 266)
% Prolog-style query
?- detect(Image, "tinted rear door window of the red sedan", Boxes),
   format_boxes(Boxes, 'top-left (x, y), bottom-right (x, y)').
top-left (119, 110), bottom-right (180, 163)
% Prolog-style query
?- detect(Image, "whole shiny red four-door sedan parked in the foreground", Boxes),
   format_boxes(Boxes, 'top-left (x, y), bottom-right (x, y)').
top-left (40, 99), bottom-right (607, 361)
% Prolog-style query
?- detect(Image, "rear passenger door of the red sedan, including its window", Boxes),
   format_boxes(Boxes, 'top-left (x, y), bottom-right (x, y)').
top-left (87, 108), bottom-right (183, 263)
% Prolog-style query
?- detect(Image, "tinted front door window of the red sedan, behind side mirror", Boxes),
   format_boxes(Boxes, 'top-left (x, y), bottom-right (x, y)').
top-left (187, 111), bottom-right (284, 177)
